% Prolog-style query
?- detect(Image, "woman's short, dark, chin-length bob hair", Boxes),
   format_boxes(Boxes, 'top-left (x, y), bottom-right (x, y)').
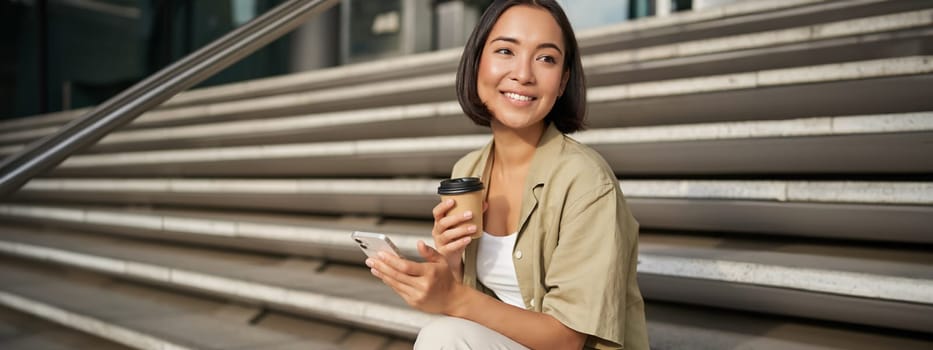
top-left (457, 0), bottom-right (586, 134)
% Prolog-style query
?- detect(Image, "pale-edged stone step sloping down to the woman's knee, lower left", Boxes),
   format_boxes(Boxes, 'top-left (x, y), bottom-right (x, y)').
top-left (0, 227), bottom-right (431, 336)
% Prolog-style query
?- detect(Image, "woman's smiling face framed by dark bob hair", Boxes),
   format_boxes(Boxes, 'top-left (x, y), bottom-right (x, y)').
top-left (476, 5), bottom-right (569, 130)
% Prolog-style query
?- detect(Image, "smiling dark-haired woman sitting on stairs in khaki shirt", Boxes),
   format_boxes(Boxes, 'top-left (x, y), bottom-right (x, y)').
top-left (366, 0), bottom-right (648, 349)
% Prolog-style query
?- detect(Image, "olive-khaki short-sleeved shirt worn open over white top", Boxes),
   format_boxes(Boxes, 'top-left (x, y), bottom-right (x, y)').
top-left (452, 125), bottom-right (648, 349)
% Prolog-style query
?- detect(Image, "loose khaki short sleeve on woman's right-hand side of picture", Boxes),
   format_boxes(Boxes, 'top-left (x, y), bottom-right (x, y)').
top-left (541, 183), bottom-right (638, 349)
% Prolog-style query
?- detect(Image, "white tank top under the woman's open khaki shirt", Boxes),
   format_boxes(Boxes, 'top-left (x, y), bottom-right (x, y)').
top-left (476, 232), bottom-right (525, 309)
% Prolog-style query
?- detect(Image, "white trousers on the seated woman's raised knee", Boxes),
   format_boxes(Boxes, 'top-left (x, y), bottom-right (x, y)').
top-left (415, 316), bottom-right (528, 350)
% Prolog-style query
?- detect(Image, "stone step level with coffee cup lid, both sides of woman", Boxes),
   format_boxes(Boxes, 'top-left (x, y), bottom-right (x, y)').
top-left (10, 179), bottom-right (933, 243)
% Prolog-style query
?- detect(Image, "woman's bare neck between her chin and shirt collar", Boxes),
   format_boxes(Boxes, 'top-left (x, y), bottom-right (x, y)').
top-left (491, 120), bottom-right (545, 172)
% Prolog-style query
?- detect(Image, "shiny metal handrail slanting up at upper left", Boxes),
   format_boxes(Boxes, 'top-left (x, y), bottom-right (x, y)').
top-left (0, 0), bottom-right (340, 197)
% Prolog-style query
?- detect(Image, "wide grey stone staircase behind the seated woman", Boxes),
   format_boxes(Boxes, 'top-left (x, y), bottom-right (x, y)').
top-left (0, 0), bottom-right (933, 349)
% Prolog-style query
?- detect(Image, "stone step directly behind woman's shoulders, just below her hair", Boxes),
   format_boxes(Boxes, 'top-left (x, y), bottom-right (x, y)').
top-left (23, 112), bottom-right (933, 176)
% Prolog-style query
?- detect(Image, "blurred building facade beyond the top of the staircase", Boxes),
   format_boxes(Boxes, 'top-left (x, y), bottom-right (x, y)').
top-left (0, 0), bottom-right (728, 118)
